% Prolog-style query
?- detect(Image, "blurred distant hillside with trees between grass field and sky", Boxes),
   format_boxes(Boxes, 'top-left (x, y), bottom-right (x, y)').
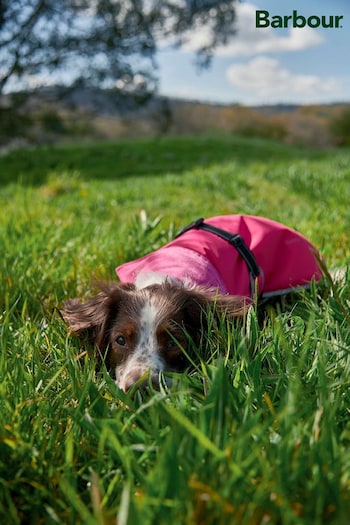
top-left (0, 86), bottom-right (350, 147)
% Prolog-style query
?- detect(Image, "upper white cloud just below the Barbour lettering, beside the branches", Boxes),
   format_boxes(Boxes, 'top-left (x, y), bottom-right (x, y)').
top-left (182, 3), bottom-right (323, 57)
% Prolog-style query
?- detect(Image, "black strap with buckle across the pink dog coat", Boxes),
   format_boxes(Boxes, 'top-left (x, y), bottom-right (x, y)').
top-left (175, 218), bottom-right (261, 293)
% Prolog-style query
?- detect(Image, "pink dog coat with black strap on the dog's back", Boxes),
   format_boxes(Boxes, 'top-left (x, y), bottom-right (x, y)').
top-left (116, 215), bottom-right (322, 298)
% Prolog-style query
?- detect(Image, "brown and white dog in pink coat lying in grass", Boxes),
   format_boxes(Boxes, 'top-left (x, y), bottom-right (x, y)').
top-left (62, 215), bottom-right (322, 392)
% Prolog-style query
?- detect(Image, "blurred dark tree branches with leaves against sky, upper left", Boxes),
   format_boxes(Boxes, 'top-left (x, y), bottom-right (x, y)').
top-left (0, 0), bottom-right (238, 93)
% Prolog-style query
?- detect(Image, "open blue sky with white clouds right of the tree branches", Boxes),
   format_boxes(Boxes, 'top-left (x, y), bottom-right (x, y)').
top-left (157, 0), bottom-right (350, 105)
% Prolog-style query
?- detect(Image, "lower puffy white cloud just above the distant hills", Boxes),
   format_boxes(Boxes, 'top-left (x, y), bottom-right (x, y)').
top-left (226, 56), bottom-right (342, 103)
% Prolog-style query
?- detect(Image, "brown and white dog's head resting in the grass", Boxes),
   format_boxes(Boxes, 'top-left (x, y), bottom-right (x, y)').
top-left (62, 281), bottom-right (244, 391)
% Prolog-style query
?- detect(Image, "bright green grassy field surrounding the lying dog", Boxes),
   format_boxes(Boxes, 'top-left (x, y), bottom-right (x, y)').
top-left (0, 136), bottom-right (350, 525)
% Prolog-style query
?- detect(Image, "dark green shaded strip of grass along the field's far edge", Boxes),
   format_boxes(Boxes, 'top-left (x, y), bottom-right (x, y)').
top-left (0, 136), bottom-right (329, 186)
